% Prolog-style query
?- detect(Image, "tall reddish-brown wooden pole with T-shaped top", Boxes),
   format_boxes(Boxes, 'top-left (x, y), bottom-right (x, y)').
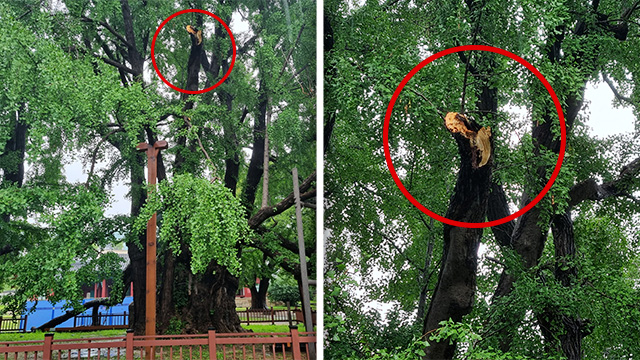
top-left (137, 140), bottom-right (168, 359)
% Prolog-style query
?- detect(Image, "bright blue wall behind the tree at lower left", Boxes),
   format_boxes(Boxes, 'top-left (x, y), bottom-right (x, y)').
top-left (23, 296), bottom-right (133, 331)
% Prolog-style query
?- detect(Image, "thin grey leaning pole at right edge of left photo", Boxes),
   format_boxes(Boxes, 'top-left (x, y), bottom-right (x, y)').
top-left (291, 168), bottom-right (316, 359)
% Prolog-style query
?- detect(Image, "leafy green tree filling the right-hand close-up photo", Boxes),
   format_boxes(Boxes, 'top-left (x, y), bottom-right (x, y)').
top-left (324, 1), bottom-right (640, 359)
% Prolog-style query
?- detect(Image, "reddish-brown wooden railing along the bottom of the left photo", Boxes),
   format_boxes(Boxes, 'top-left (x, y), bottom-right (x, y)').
top-left (0, 326), bottom-right (316, 360)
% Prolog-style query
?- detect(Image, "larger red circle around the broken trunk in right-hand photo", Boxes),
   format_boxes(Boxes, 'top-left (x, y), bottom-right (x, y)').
top-left (382, 45), bottom-right (567, 228)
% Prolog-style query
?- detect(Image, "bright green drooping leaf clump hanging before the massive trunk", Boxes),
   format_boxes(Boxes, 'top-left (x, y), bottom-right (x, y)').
top-left (134, 174), bottom-right (250, 274)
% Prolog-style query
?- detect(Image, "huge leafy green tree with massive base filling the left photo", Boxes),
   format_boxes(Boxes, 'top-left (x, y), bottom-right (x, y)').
top-left (0, 0), bottom-right (315, 333)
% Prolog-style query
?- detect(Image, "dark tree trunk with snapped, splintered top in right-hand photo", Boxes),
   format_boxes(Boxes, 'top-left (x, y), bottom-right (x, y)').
top-left (423, 113), bottom-right (493, 359)
